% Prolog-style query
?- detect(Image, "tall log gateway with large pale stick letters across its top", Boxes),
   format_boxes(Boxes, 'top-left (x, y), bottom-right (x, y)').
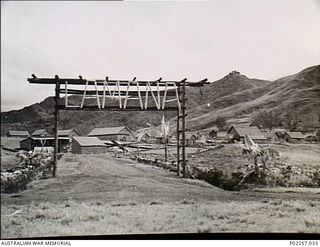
top-left (28, 74), bottom-right (209, 177)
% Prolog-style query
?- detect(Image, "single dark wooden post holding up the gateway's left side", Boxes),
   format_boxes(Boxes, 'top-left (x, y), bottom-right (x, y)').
top-left (52, 75), bottom-right (60, 177)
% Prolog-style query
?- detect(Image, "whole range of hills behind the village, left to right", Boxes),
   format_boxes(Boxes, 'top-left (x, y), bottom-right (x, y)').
top-left (1, 65), bottom-right (320, 135)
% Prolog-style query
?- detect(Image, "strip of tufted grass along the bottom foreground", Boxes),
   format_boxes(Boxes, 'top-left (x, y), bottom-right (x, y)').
top-left (1, 199), bottom-right (320, 238)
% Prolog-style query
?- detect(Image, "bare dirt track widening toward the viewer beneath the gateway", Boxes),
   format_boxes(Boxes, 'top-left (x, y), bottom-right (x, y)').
top-left (2, 155), bottom-right (233, 204)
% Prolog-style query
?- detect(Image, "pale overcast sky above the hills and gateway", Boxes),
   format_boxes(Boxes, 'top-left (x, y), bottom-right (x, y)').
top-left (1, 0), bottom-right (320, 111)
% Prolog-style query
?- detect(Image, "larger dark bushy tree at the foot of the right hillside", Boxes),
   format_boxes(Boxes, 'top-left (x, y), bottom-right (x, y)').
top-left (251, 110), bottom-right (281, 131)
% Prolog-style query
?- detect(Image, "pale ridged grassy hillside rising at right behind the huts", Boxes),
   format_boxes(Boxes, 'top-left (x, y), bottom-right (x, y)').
top-left (188, 66), bottom-right (320, 129)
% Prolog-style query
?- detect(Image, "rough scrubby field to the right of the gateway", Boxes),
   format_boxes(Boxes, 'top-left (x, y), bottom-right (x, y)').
top-left (188, 144), bottom-right (320, 190)
